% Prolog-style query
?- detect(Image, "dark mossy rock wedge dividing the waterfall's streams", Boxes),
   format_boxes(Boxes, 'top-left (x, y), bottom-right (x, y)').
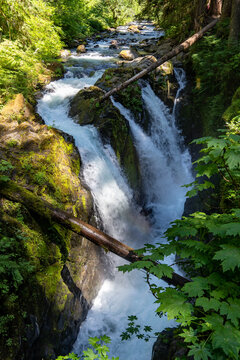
top-left (69, 86), bottom-right (141, 196)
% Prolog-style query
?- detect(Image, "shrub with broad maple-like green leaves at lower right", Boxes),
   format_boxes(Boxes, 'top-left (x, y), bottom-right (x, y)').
top-left (120, 131), bottom-right (240, 360)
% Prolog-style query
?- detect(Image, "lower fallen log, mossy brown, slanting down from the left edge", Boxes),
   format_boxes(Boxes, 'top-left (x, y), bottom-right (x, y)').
top-left (0, 178), bottom-right (190, 286)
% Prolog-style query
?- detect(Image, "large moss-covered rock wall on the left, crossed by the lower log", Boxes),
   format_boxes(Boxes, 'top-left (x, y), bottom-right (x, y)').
top-left (0, 94), bottom-right (106, 360)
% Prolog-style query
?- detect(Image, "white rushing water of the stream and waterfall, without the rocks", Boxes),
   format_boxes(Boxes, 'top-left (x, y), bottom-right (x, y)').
top-left (38, 23), bottom-right (192, 360)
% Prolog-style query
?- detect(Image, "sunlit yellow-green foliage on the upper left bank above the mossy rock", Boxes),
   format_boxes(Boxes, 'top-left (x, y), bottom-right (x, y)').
top-left (0, 0), bottom-right (62, 103)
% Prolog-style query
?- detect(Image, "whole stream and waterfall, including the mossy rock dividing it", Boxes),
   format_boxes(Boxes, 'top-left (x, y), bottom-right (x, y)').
top-left (37, 22), bottom-right (195, 360)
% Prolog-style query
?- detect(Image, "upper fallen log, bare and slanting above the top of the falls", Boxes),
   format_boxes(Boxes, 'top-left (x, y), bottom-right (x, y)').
top-left (98, 19), bottom-right (218, 102)
